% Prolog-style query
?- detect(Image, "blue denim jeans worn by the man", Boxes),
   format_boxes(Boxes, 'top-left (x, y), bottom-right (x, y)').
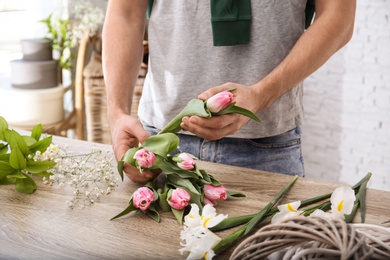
top-left (144, 125), bottom-right (304, 177)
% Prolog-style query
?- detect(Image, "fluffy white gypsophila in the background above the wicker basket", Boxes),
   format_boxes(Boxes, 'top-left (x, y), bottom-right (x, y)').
top-left (71, 0), bottom-right (104, 43)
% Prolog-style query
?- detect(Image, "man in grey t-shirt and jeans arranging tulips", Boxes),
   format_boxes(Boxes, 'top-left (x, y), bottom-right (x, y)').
top-left (103, 0), bottom-right (356, 183)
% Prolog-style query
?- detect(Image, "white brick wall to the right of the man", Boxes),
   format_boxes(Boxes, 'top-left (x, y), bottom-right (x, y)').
top-left (302, 0), bottom-right (390, 191)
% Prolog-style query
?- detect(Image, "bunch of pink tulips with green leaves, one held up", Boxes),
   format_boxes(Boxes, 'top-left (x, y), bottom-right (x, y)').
top-left (112, 89), bottom-right (260, 224)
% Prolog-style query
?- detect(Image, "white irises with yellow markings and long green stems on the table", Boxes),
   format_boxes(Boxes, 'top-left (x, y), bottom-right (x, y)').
top-left (179, 173), bottom-right (371, 259)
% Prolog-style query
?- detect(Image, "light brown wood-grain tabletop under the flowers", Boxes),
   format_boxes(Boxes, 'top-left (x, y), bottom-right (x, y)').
top-left (0, 133), bottom-right (390, 259)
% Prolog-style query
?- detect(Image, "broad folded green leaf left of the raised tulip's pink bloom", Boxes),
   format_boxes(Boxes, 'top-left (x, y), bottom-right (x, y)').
top-left (158, 99), bottom-right (211, 134)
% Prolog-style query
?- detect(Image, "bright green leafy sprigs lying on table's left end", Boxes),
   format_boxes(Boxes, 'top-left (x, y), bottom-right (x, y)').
top-left (0, 116), bottom-right (56, 193)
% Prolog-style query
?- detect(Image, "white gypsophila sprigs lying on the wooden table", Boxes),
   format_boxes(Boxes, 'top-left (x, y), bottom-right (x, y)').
top-left (34, 145), bottom-right (118, 208)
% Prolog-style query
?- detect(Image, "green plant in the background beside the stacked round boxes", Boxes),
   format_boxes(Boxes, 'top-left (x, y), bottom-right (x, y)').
top-left (39, 14), bottom-right (75, 70)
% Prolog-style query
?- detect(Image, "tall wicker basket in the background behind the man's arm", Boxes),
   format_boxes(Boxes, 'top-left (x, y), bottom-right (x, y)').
top-left (84, 41), bottom-right (148, 144)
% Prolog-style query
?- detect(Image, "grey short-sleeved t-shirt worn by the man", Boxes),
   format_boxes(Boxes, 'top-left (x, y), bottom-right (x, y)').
top-left (138, 0), bottom-right (306, 138)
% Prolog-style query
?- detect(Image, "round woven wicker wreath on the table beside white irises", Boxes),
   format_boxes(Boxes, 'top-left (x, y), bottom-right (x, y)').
top-left (230, 217), bottom-right (390, 260)
